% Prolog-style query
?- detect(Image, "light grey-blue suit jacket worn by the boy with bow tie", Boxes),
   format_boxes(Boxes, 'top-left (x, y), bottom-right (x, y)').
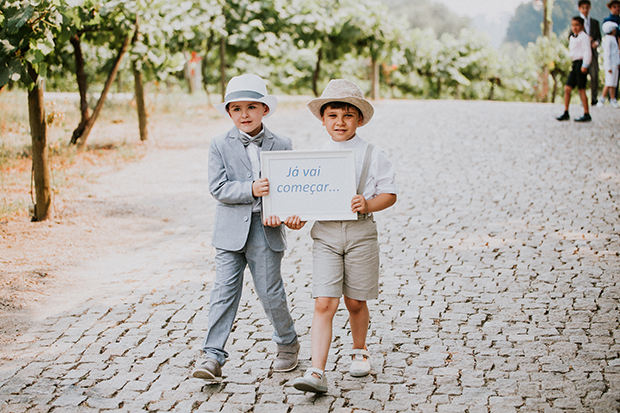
top-left (209, 125), bottom-right (293, 251)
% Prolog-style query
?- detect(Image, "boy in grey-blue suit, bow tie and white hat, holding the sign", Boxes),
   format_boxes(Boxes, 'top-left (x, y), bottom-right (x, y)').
top-left (192, 74), bottom-right (302, 382)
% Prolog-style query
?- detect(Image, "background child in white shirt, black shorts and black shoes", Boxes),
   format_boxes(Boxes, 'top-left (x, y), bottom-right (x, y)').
top-left (556, 16), bottom-right (592, 122)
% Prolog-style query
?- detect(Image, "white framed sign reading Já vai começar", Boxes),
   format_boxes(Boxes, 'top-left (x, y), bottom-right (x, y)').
top-left (261, 150), bottom-right (357, 221)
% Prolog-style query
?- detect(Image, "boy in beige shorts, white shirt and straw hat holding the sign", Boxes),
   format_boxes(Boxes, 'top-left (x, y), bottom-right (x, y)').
top-left (293, 79), bottom-right (397, 393)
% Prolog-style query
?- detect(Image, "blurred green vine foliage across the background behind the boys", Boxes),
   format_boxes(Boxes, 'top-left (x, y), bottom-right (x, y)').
top-left (0, 0), bottom-right (608, 101)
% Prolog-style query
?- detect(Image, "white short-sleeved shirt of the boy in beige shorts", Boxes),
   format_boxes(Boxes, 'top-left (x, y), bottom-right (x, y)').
top-left (321, 135), bottom-right (398, 199)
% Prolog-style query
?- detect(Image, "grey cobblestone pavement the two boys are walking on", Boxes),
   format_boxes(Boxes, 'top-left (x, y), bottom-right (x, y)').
top-left (0, 101), bottom-right (620, 413)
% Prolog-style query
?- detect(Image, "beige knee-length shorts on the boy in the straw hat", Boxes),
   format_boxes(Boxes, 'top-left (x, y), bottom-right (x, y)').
top-left (310, 218), bottom-right (379, 301)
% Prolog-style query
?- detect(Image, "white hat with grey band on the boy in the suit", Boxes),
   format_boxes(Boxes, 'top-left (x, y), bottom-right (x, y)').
top-left (213, 74), bottom-right (278, 118)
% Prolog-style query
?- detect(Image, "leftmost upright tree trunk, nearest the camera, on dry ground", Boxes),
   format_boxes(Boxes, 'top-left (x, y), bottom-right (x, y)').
top-left (28, 65), bottom-right (52, 221)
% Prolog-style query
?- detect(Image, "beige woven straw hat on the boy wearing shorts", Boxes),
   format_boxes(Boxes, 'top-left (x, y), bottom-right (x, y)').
top-left (308, 79), bottom-right (375, 126)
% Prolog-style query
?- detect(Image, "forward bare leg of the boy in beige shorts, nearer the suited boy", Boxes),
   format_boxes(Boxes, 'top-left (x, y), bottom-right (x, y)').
top-left (310, 297), bottom-right (340, 370)
